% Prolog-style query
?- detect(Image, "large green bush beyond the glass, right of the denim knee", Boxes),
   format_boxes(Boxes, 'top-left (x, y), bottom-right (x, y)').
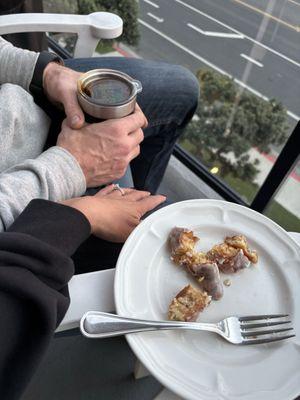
top-left (183, 70), bottom-right (288, 180)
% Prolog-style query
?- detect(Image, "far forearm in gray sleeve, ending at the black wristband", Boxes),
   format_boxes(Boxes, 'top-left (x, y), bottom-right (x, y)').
top-left (0, 37), bottom-right (39, 91)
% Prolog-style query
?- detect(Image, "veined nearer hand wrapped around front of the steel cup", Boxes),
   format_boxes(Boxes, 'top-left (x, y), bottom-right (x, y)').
top-left (57, 106), bottom-right (147, 187)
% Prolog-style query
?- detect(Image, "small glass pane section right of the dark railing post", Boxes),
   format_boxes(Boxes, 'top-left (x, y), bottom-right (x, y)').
top-left (265, 162), bottom-right (300, 232)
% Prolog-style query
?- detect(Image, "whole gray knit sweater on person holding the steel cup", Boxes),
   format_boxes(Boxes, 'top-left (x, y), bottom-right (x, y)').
top-left (0, 37), bottom-right (86, 232)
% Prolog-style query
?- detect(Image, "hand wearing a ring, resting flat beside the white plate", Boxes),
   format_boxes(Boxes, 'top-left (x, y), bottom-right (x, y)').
top-left (62, 185), bottom-right (166, 243)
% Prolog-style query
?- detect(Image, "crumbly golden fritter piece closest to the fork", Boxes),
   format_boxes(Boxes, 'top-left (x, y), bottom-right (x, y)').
top-left (168, 285), bottom-right (211, 322)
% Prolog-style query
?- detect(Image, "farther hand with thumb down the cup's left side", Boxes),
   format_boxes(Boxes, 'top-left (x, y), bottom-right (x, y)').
top-left (43, 62), bottom-right (84, 129)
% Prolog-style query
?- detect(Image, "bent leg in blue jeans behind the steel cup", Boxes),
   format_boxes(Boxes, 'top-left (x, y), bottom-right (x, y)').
top-left (66, 57), bottom-right (199, 193)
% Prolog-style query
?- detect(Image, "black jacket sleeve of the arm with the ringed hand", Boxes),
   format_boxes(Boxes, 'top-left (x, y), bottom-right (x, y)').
top-left (0, 200), bottom-right (91, 400)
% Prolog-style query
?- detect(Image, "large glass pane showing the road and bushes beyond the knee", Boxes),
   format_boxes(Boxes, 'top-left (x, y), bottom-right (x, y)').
top-left (134, 0), bottom-right (300, 203)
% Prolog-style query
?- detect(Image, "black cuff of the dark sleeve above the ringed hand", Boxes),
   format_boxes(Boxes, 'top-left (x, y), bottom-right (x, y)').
top-left (7, 199), bottom-right (91, 256)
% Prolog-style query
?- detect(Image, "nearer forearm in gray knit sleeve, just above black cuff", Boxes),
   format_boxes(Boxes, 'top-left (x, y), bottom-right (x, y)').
top-left (0, 147), bottom-right (86, 232)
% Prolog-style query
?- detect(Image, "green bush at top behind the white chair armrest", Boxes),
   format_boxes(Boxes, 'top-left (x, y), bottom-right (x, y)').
top-left (77, 0), bottom-right (140, 45)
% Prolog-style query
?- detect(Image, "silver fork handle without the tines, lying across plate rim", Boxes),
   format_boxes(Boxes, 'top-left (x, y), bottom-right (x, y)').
top-left (80, 311), bottom-right (218, 338)
